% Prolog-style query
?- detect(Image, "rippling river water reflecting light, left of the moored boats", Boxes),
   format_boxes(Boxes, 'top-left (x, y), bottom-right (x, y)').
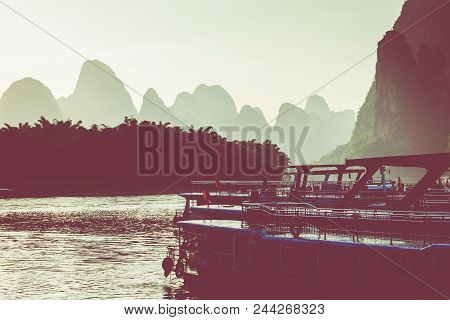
top-left (0, 195), bottom-right (195, 299)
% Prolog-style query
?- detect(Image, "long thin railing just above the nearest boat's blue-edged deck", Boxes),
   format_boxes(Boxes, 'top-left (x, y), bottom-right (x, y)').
top-left (243, 203), bottom-right (450, 222)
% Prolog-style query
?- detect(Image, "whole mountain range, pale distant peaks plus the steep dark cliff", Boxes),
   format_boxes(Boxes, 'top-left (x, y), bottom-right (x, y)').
top-left (0, 0), bottom-right (450, 168)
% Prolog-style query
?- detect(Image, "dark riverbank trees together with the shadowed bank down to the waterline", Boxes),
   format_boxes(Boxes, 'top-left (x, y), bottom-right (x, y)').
top-left (0, 117), bottom-right (288, 198)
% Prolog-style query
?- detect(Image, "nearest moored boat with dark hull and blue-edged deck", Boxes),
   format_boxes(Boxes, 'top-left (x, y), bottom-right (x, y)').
top-left (168, 220), bottom-right (450, 299)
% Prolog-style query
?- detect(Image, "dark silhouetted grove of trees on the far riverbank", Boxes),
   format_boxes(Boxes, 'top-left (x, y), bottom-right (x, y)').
top-left (0, 118), bottom-right (287, 189)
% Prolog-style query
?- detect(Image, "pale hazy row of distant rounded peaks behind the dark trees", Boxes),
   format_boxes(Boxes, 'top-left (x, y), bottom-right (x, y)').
top-left (0, 60), bottom-right (355, 161)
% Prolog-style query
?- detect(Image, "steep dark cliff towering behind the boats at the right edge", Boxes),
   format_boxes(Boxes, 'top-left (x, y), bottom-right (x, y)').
top-left (322, 0), bottom-right (450, 162)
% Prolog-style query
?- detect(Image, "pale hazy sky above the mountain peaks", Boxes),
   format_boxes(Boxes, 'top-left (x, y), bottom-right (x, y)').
top-left (0, 0), bottom-right (404, 120)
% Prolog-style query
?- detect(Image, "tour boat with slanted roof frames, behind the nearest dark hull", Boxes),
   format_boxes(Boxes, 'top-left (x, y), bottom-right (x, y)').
top-left (178, 153), bottom-right (450, 219)
